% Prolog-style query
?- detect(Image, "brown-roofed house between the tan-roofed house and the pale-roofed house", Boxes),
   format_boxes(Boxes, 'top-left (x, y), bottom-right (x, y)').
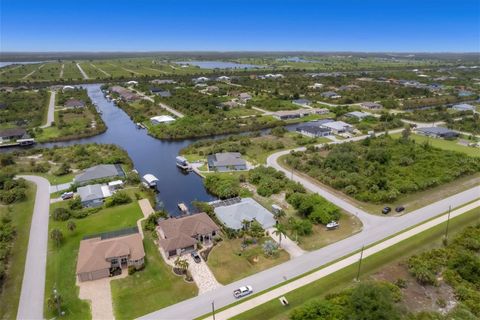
top-left (156, 212), bottom-right (220, 258)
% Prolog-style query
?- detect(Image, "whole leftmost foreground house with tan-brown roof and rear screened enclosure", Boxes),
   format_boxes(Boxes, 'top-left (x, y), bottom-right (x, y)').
top-left (76, 227), bottom-right (145, 281)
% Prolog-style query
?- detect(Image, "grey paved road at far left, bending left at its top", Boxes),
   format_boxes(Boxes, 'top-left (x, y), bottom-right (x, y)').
top-left (17, 176), bottom-right (50, 319)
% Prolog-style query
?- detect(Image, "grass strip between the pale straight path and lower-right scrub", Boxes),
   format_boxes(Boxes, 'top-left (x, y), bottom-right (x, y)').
top-left (232, 208), bottom-right (480, 320)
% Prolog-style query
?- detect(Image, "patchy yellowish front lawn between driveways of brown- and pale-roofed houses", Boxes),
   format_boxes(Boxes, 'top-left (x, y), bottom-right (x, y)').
top-left (207, 238), bottom-right (289, 284)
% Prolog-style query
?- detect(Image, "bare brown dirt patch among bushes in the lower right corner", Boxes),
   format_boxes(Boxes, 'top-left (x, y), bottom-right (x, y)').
top-left (371, 262), bottom-right (457, 314)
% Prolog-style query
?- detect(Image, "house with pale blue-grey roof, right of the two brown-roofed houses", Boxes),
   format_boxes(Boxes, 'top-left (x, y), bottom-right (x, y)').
top-left (214, 198), bottom-right (275, 230)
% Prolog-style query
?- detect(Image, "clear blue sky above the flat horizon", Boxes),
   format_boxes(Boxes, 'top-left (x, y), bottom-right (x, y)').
top-left (0, 0), bottom-right (480, 52)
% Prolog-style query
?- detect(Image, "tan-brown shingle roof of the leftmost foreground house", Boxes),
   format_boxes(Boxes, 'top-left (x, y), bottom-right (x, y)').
top-left (77, 233), bottom-right (145, 274)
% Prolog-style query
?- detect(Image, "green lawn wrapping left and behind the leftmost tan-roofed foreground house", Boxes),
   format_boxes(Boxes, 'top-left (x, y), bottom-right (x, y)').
top-left (45, 201), bottom-right (143, 319)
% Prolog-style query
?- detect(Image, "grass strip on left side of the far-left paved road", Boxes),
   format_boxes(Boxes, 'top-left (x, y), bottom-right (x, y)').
top-left (0, 183), bottom-right (36, 319)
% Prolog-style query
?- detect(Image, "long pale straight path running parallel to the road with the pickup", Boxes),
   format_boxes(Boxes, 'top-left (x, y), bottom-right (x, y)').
top-left (205, 201), bottom-right (480, 320)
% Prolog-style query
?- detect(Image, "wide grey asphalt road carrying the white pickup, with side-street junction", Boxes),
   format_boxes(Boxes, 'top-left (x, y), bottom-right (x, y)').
top-left (140, 175), bottom-right (480, 319)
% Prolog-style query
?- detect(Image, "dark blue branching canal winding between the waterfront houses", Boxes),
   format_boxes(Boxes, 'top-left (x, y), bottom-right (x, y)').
top-left (41, 84), bottom-right (214, 215)
